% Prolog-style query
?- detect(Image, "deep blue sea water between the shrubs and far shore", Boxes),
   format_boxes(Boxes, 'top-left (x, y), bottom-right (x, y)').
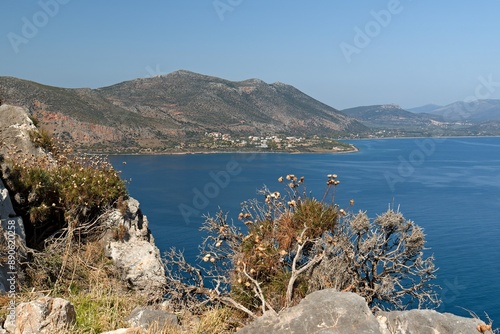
top-left (110, 138), bottom-right (500, 324)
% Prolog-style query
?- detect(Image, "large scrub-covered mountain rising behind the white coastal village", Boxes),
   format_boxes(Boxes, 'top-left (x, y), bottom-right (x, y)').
top-left (0, 70), bottom-right (367, 150)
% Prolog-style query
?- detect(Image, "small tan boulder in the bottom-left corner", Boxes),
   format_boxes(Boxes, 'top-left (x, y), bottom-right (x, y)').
top-left (4, 297), bottom-right (76, 334)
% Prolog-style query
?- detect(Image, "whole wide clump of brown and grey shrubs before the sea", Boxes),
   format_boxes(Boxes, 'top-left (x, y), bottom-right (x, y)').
top-left (162, 175), bottom-right (439, 317)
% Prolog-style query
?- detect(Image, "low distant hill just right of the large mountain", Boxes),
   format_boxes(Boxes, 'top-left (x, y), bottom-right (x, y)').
top-left (342, 104), bottom-right (432, 130)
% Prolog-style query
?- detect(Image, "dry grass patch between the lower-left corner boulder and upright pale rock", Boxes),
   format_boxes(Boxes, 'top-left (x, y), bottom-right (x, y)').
top-left (19, 236), bottom-right (147, 333)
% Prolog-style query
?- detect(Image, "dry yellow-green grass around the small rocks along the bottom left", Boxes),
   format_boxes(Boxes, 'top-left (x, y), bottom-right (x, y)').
top-left (7, 235), bottom-right (239, 334)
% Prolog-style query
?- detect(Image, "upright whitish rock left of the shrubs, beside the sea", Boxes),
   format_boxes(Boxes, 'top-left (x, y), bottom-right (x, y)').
top-left (106, 198), bottom-right (167, 300)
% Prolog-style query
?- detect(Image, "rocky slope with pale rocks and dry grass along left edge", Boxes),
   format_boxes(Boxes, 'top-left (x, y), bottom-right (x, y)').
top-left (0, 105), bottom-right (166, 333)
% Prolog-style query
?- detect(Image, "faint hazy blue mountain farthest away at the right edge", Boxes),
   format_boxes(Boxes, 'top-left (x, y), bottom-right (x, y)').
top-left (424, 99), bottom-right (500, 123)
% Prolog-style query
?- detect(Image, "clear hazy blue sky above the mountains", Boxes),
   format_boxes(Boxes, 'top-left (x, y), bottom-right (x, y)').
top-left (0, 0), bottom-right (500, 109)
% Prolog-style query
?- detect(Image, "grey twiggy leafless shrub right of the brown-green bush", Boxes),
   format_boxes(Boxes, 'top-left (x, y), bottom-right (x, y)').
top-left (309, 209), bottom-right (440, 310)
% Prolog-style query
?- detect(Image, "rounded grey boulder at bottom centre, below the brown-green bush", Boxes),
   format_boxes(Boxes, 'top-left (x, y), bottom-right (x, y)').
top-left (238, 289), bottom-right (379, 334)
